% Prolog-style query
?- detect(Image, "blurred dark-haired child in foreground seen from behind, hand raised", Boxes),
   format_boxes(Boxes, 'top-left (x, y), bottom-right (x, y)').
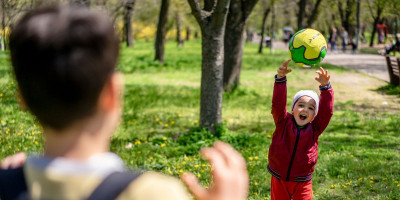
top-left (0, 7), bottom-right (248, 200)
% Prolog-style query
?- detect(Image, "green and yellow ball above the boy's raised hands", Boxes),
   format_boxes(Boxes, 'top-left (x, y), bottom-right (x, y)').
top-left (289, 28), bottom-right (327, 67)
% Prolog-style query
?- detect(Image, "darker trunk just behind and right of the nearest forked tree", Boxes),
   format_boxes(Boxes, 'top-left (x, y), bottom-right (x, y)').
top-left (223, 0), bottom-right (258, 92)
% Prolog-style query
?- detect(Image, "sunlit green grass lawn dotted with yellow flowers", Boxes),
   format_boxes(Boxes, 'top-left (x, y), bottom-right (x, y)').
top-left (0, 41), bottom-right (400, 199)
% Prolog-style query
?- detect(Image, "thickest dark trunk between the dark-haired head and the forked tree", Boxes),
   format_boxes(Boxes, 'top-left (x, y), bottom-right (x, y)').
top-left (155, 0), bottom-right (170, 62)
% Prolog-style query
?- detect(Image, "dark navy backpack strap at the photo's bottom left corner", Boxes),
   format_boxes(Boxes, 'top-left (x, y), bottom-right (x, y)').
top-left (0, 167), bottom-right (27, 200)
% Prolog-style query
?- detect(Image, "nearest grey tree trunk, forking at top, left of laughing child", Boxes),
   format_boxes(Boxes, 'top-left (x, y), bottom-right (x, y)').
top-left (188, 0), bottom-right (230, 134)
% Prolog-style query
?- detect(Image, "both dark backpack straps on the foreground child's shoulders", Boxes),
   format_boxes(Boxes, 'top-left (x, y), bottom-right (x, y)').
top-left (0, 167), bottom-right (141, 200)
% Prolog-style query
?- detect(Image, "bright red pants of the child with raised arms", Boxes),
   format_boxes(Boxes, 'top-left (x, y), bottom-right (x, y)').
top-left (271, 176), bottom-right (312, 200)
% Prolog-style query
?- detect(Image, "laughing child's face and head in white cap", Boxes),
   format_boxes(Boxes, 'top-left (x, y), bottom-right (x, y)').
top-left (292, 90), bottom-right (319, 126)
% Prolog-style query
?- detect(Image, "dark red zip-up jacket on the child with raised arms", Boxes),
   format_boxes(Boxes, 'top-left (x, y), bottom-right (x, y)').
top-left (268, 77), bottom-right (333, 182)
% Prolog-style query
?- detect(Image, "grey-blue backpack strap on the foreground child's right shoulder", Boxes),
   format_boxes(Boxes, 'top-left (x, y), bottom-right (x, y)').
top-left (87, 172), bottom-right (141, 200)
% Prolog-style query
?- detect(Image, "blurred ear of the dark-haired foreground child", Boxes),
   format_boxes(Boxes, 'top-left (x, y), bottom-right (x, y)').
top-left (98, 72), bottom-right (124, 111)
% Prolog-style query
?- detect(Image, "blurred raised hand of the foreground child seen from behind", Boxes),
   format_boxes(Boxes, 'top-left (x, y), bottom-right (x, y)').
top-left (182, 142), bottom-right (249, 200)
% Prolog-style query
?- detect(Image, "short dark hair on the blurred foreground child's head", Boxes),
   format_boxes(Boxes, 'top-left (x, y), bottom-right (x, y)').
top-left (10, 6), bottom-right (119, 130)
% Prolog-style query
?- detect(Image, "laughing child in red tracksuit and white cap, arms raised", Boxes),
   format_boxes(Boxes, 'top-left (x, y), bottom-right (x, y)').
top-left (268, 60), bottom-right (333, 200)
